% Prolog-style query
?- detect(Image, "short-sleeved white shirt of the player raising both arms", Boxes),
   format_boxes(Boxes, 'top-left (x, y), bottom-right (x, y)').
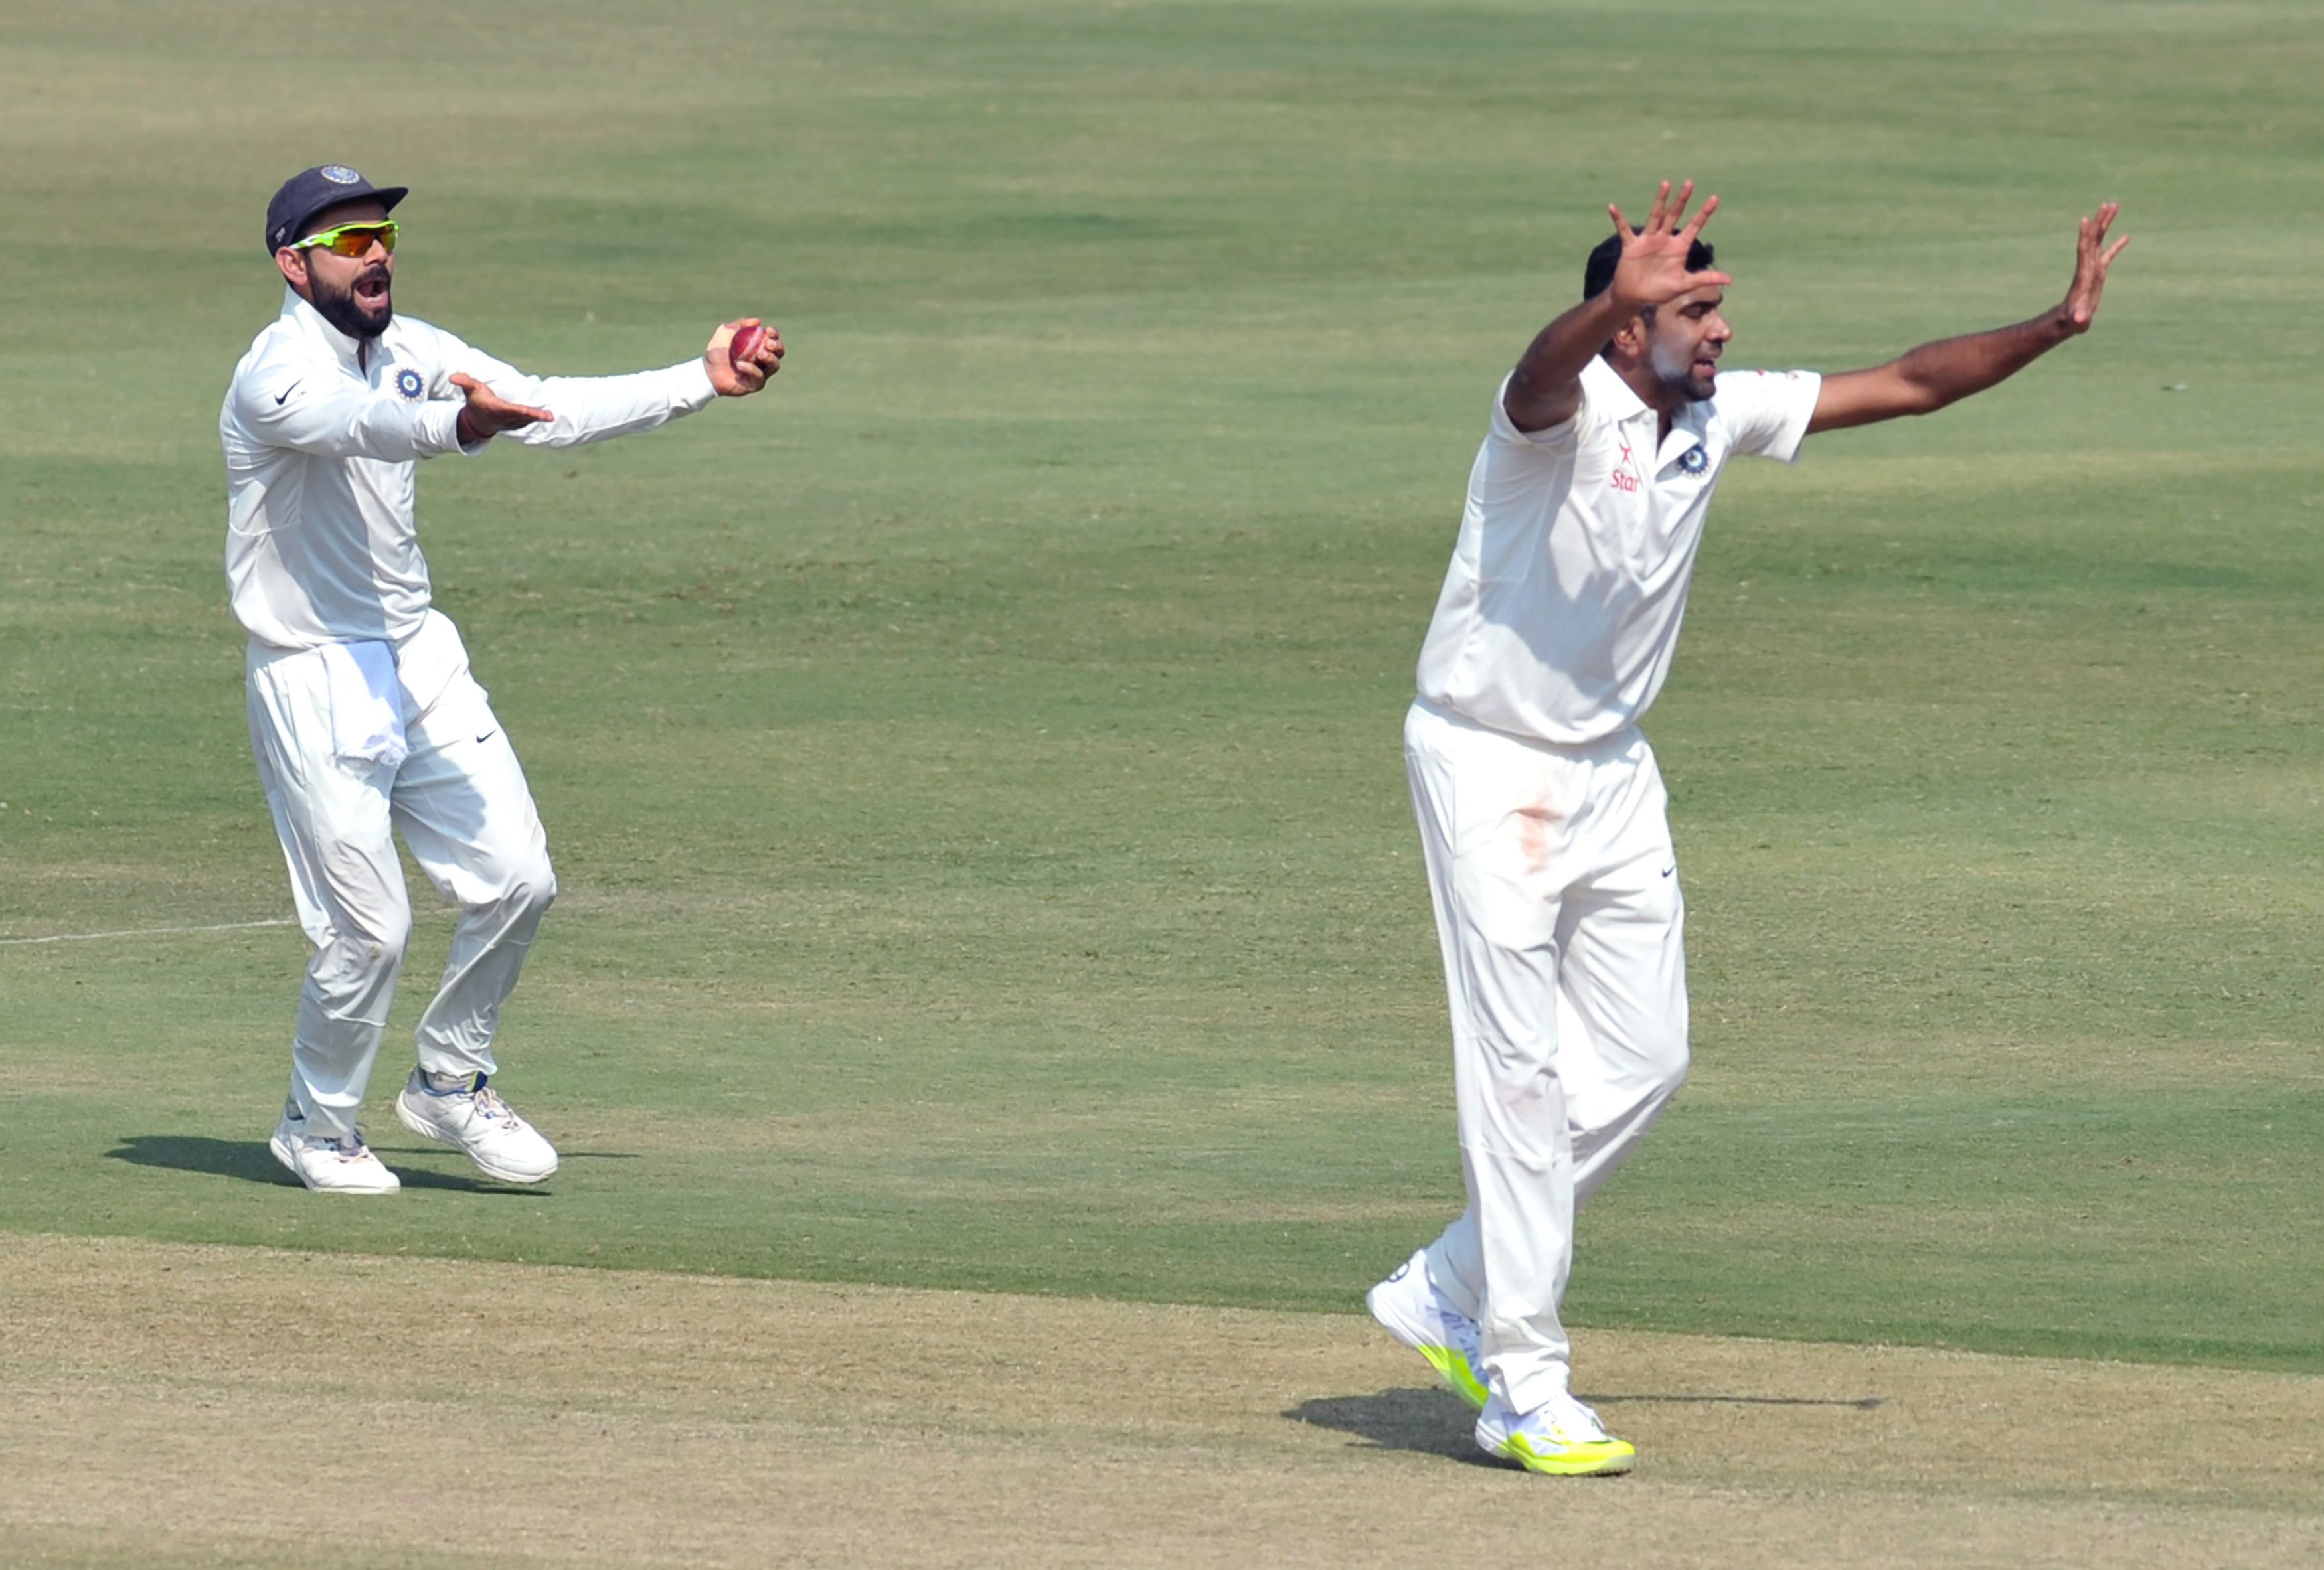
top-left (1420, 360), bottom-right (1822, 746)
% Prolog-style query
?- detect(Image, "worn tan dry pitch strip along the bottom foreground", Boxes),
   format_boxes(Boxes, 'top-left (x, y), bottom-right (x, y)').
top-left (0, 1235), bottom-right (2324, 1570)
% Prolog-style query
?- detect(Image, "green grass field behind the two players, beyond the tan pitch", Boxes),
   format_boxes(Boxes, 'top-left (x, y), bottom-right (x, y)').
top-left (0, 0), bottom-right (2324, 1373)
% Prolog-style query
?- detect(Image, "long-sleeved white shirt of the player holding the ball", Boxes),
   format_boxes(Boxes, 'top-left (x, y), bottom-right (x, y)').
top-left (218, 288), bottom-right (718, 648)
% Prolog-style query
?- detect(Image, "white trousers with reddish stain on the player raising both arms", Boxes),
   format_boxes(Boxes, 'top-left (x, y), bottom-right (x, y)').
top-left (1404, 702), bottom-right (1687, 1412)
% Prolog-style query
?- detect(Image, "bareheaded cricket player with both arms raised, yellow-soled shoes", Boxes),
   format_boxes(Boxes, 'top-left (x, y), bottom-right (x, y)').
top-left (1367, 181), bottom-right (2129, 1475)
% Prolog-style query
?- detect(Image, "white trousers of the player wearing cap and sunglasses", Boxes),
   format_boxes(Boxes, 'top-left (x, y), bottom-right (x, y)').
top-left (249, 611), bottom-right (558, 1138)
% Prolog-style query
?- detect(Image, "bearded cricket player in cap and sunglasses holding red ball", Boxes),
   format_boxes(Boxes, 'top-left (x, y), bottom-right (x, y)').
top-left (218, 165), bottom-right (784, 1194)
